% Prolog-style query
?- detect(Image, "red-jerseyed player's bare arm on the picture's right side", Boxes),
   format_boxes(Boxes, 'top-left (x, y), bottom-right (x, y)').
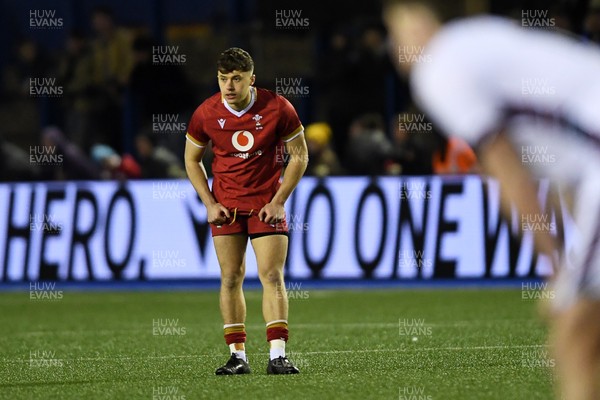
top-left (258, 133), bottom-right (308, 224)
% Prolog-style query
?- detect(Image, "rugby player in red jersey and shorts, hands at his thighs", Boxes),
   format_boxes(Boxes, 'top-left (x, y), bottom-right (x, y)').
top-left (185, 48), bottom-right (308, 375)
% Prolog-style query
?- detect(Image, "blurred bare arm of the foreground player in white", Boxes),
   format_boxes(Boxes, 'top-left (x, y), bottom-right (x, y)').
top-left (479, 134), bottom-right (558, 271)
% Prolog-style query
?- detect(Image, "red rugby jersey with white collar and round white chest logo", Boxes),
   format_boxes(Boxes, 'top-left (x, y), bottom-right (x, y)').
top-left (186, 87), bottom-right (304, 212)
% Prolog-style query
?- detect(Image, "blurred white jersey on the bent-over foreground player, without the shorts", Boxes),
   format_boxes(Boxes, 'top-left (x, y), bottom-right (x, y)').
top-left (411, 17), bottom-right (600, 150)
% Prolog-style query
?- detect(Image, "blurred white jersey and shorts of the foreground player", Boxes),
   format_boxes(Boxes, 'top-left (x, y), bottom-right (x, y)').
top-left (411, 17), bottom-right (600, 303)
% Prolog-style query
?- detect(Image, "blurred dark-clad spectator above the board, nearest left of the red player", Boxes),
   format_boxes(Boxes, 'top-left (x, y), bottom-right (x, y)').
top-left (135, 133), bottom-right (187, 179)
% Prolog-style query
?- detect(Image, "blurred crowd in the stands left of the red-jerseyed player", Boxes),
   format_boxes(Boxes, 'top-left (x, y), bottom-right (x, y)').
top-left (0, 7), bottom-right (195, 181)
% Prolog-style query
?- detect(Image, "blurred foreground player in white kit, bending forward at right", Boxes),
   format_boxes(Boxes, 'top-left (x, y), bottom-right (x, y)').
top-left (384, 0), bottom-right (600, 400)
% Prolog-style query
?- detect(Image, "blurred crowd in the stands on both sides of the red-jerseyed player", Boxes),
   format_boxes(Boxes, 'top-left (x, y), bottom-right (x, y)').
top-left (0, 3), bottom-right (600, 181)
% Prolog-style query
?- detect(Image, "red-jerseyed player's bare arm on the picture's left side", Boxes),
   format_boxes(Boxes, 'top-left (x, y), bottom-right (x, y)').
top-left (184, 139), bottom-right (229, 225)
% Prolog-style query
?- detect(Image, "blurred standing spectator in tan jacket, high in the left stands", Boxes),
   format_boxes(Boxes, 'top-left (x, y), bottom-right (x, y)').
top-left (88, 7), bottom-right (133, 153)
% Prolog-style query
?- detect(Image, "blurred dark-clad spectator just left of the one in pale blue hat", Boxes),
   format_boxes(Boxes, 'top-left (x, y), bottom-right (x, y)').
top-left (41, 127), bottom-right (100, 180)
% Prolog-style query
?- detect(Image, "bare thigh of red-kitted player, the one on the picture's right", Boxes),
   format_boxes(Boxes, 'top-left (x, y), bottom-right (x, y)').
top-left (251, 234), bottom-right (288, 278)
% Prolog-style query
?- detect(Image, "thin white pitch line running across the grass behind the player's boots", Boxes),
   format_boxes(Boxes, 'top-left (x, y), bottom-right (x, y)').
top-left (2, 344), bottom-right (550, 363)
